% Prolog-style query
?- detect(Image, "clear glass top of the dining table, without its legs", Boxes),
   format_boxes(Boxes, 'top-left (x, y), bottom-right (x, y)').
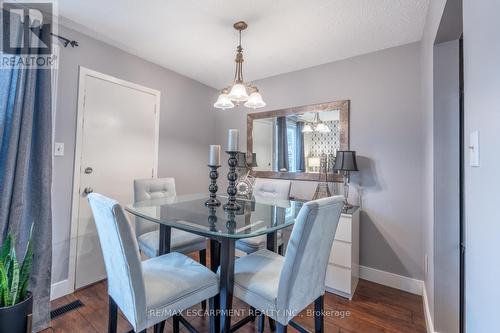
top-left (125, 194), bottom-right (304, 238)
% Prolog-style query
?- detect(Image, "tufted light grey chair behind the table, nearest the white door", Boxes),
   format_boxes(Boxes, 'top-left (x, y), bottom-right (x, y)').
top-left (134, 178), bottom-right (206, 258)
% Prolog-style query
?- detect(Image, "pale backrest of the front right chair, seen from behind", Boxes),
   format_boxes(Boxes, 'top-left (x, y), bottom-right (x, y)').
top-left (277, 196), bottom-right (344, 323)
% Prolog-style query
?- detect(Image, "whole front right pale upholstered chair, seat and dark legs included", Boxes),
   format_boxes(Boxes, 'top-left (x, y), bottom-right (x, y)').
top-left (230, 196), bottom-right (344, 332)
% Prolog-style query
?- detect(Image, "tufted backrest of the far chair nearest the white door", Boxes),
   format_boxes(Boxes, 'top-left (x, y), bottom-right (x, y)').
top-left (134, 178), bottom-right (176, 237)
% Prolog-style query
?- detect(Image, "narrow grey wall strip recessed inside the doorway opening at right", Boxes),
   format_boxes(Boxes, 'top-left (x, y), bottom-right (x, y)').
top-left (434, 40), bottom-right (460, 333)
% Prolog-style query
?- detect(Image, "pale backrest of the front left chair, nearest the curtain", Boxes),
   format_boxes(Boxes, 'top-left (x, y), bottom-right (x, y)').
top-left (88, 193), bottom-right (147, 329)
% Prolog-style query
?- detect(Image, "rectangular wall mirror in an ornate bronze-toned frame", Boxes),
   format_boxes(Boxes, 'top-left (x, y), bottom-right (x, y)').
top-left (247, 100), bottom-right (349, 182)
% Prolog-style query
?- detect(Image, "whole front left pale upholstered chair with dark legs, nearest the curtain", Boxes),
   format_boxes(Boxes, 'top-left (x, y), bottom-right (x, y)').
top-left (88, 193), bottom-right (219, 333)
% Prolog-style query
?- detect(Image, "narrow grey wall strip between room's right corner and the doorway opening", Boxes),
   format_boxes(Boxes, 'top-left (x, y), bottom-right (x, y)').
top-left (420, 0), bottom-right (446, 320)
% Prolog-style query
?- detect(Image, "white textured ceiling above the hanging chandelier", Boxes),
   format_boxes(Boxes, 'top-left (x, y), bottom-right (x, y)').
top-left (59, 0), bottom-right (429, 88)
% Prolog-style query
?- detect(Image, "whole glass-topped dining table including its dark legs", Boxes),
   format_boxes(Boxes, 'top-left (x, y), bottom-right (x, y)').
top-left (125, 194), bottom-right (303, 332)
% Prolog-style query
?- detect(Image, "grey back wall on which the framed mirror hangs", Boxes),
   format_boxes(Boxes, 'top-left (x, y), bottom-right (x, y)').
top-left (217, 43), bottom-right (425, 279)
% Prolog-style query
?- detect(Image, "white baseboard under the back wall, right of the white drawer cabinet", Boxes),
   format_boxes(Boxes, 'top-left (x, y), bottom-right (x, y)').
top-left (359, 266), bottom-right (424, 296)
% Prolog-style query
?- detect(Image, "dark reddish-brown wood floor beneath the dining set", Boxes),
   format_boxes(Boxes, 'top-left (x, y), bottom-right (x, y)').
top-left (43, 250), bottom-right (426, 333)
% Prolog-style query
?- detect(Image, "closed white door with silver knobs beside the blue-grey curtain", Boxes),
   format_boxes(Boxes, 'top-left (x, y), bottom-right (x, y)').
top-left (75, 70), bottom-right (159, 289)
